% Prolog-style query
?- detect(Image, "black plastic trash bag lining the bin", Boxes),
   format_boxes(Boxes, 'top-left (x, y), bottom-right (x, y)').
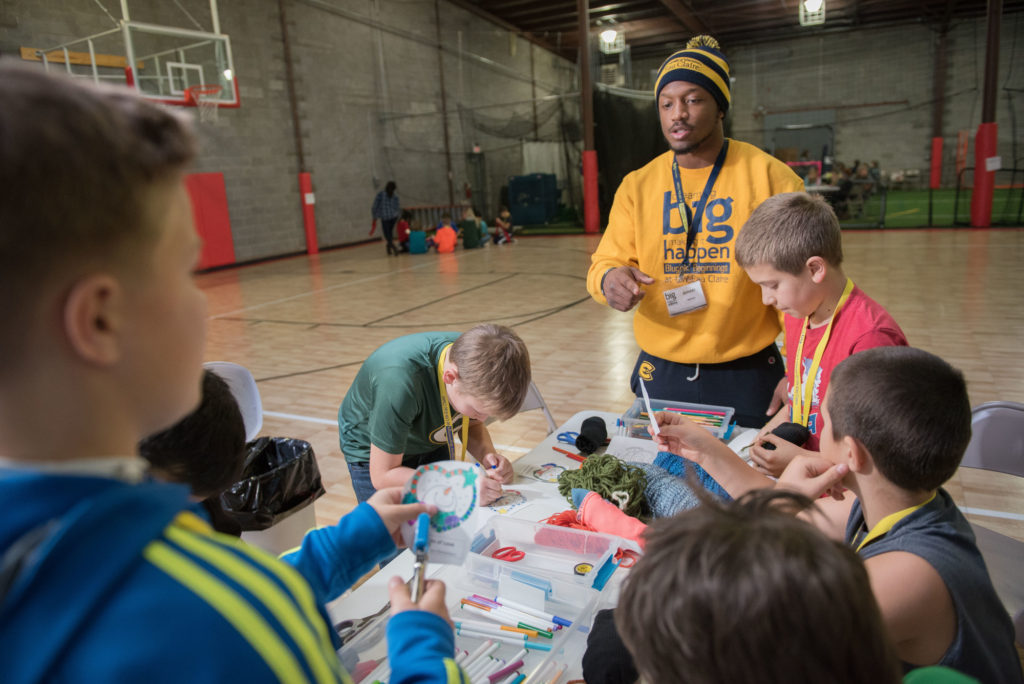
top-left (220, 437), bottom-right (324, 531)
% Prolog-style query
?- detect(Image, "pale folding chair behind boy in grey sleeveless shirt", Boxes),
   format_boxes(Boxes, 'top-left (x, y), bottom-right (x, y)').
top-left (961, 401), bottom-right (1024, 645)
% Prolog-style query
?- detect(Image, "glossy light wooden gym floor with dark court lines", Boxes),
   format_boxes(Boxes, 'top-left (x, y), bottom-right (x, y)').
top-left (199, 229), bottom-right (1024, 541)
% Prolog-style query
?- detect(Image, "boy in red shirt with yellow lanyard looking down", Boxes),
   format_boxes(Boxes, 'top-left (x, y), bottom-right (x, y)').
top-left (736, 188), bottom-right (907, 476)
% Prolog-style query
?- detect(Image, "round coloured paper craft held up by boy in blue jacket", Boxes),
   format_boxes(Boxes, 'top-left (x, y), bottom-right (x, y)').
top-left (401, 461), bottom-right (481, 563)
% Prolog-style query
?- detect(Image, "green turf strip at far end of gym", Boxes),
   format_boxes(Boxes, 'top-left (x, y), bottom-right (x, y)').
top-left (521, 187), bottom-right (1024, 236)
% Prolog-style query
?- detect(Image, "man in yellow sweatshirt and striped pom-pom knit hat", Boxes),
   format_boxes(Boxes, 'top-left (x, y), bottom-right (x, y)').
top-left (587, 36), bottom-right (804, 426)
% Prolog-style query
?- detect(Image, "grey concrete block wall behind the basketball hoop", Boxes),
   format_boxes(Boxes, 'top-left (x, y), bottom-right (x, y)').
top-left (0, 0), bottom-right (579, 261)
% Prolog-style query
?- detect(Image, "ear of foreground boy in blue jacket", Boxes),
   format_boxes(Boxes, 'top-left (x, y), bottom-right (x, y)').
top-left (62, 273), bottom-right (124, 366)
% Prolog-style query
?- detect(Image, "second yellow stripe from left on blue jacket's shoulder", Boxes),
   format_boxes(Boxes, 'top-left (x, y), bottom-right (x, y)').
top-left (164, 525), bottom-right (340, 682)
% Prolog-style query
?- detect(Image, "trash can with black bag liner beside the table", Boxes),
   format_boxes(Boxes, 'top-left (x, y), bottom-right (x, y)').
top-left (220, 437), bottom-right (324, 554)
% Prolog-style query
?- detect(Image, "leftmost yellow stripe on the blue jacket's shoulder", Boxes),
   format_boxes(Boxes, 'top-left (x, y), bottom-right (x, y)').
top-left (142, 541), bottom-right (307, 682)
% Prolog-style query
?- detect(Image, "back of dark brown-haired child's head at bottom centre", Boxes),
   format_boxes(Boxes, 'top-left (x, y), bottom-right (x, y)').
top-left (610, 490), bottom-right (975, 684)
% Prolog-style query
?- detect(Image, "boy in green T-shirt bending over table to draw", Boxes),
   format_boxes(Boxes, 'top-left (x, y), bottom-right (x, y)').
top-left (338, 324), bottom-right (530, 504)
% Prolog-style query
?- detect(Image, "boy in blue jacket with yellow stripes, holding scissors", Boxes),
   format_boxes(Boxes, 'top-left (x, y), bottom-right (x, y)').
top-left (0, 59), bottom-right (455, 684)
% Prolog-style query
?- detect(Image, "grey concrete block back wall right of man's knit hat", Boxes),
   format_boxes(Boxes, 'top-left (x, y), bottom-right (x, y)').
top-left (634, 12), bottom-right (1024, 185)
